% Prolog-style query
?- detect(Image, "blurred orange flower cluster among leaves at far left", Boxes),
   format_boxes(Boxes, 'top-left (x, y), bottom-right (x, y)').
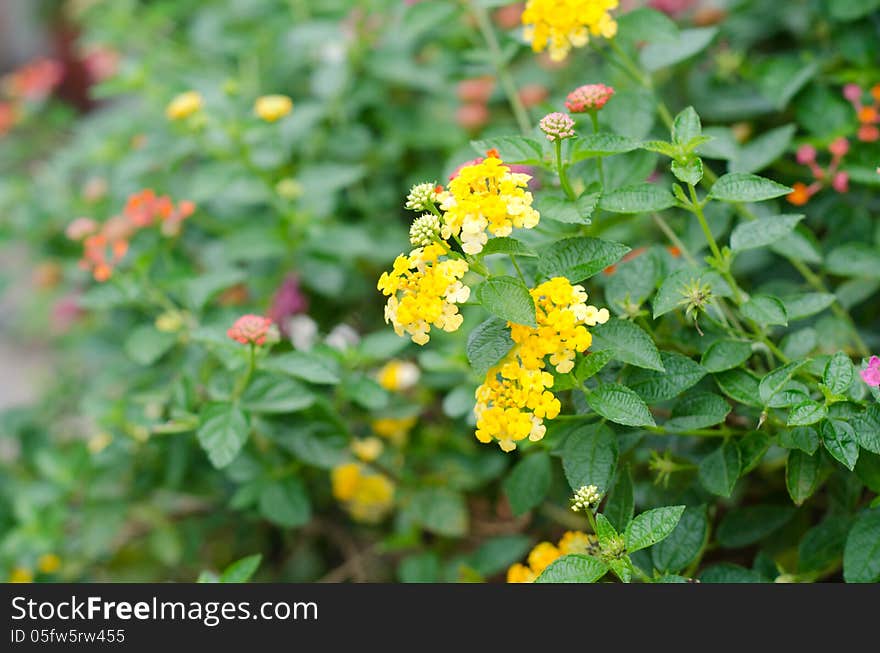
top-left (66, 188), bottom-right (196, 281)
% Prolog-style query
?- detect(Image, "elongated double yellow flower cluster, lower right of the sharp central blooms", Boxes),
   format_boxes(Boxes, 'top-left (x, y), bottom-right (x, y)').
top-left (474, 277), bottom-right (609, 451)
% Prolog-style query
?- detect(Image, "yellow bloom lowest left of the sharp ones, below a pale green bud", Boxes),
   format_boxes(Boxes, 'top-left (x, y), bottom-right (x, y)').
top-left (377, 243), bottom-right (470, 345)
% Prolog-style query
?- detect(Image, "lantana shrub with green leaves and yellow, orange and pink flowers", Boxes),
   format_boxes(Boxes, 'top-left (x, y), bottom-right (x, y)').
top-left (0, 0), bottom-right (880, 583)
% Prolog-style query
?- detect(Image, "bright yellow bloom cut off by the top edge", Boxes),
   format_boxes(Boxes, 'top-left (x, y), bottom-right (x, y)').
top-left (522, 0), bottom-right (617, 61)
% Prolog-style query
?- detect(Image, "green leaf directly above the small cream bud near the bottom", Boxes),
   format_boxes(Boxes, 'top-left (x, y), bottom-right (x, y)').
top-left (562, 424), bottom-right (617, 492)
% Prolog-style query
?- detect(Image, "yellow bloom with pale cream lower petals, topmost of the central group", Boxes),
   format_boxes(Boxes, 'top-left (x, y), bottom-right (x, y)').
top-left (440, 156), bottom-right (541, 254)
